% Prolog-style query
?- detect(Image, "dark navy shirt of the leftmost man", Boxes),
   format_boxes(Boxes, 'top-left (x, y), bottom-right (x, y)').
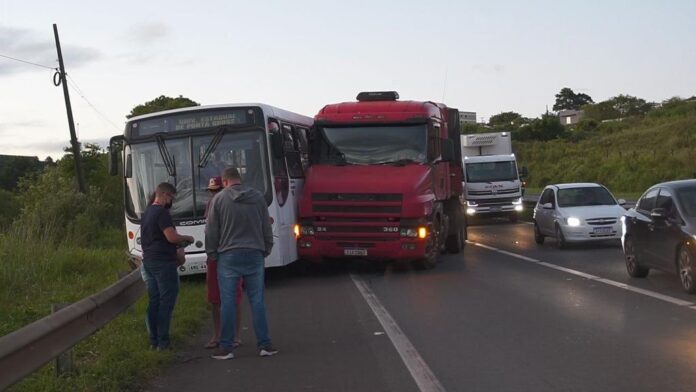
top-left (140, 204), bottom-right (176, 263)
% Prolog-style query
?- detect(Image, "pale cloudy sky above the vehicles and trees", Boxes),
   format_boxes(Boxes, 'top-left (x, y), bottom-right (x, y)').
top-left (0, 0), bottom-right (696, 159)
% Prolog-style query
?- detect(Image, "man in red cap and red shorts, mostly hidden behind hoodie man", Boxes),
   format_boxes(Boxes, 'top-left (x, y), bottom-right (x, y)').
top-left (205, 176), bottom-right (243, 349)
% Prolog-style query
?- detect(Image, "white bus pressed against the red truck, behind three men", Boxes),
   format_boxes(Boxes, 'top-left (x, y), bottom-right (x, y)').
top-left (109, 104), bottom-right (312, 275)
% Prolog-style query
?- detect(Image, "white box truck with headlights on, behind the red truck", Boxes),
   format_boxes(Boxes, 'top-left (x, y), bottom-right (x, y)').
top-left (461, 132), bottom-right (526, 222)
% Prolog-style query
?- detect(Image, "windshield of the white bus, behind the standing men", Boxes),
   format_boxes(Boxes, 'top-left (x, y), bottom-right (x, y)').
top-left (126, 131), bottom-right (271, 220)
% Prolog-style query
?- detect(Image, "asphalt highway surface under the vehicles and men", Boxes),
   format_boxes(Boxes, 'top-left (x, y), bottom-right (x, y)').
top-left (150, 222), bottom-right (696, 391)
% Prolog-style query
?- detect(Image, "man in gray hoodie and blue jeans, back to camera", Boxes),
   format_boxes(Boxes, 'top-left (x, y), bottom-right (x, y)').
top-left (205, 168), bottom-right (278, 359)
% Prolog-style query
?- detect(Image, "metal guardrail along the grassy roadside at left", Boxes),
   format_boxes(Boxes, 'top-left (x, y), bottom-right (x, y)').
top-left (0, 268), bottom-right (145, 390)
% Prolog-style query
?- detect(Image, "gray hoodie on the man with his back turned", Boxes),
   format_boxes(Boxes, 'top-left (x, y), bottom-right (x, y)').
top-left (205, 185), bottom-right (273, 260)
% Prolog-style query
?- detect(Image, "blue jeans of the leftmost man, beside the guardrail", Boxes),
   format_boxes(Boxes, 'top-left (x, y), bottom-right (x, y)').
top-left (140, 260), bottom-right (179, 348)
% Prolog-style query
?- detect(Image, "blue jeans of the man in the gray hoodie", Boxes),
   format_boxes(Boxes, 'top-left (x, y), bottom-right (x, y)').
top-left (217, 249), bottom-right (271, 350)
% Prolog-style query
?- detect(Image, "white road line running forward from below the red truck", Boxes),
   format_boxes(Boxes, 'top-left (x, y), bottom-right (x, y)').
top-left (350, 274), bottom-right (445, 392)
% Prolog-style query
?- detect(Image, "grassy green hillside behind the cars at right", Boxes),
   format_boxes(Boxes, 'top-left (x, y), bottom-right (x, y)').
top-left (513, 100), bottom-right (696, 192)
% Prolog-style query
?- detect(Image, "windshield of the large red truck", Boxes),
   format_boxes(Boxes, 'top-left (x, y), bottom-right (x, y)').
top-left (319, 124), bottom-right (427, 165)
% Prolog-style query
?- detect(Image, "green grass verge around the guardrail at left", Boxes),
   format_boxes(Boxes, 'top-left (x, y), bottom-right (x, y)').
top-left (0, 234), bottom-right (208, 391)
